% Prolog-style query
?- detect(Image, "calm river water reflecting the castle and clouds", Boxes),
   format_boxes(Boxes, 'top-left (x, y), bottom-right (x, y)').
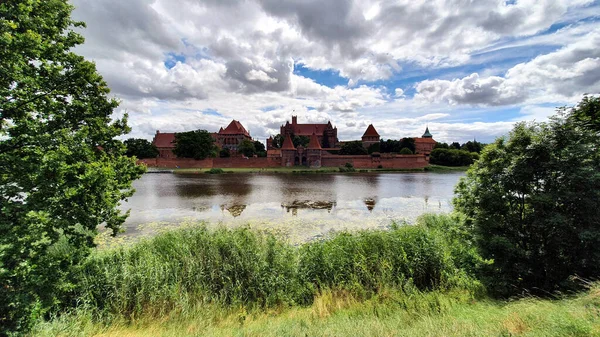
top-left (123, 172), bottom-right (463, 240)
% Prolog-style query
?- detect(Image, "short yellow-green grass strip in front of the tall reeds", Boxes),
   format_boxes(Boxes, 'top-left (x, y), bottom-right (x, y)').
top-left (35, 284), bottom-right (600, 337)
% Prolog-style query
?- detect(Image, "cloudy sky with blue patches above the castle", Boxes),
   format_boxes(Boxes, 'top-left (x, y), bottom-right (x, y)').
top-left (72, 0), bottom-right (600, 143)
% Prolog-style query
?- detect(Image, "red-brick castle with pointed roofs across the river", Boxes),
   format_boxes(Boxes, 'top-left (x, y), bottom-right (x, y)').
top-left (152, 116), bottom-right (436, 168)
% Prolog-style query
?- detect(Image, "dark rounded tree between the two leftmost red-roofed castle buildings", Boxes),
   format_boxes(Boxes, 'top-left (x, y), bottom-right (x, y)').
top-left (173, 130), bottom-right (218, 160)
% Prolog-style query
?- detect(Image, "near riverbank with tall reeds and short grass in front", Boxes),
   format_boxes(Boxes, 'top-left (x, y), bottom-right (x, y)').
top-left (31, 214), bottom-right (600, 336)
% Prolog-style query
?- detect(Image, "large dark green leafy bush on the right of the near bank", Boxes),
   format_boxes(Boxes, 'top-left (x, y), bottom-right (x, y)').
top-left (454, 100), bottom-right (600, 295)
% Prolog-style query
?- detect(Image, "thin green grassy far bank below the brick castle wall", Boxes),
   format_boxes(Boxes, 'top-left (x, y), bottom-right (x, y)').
top-left (171, 165), bottom-right (469, 174)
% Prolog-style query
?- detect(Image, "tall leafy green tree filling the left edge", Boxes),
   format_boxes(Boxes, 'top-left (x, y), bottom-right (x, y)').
top-left (0, 0), bottom-right (144, 335)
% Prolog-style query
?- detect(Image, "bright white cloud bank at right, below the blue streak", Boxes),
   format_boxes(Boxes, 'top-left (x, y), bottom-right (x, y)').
top-left (415, 30), bottom-right (600, 106)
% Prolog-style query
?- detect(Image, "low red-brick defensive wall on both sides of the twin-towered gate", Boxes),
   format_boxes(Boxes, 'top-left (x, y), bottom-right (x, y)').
top-left (138, 154), bottom-right (429, 169)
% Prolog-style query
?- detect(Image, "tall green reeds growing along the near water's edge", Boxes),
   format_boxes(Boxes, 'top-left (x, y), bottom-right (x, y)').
top-left (35, 215), bottom-right (481, 332)
